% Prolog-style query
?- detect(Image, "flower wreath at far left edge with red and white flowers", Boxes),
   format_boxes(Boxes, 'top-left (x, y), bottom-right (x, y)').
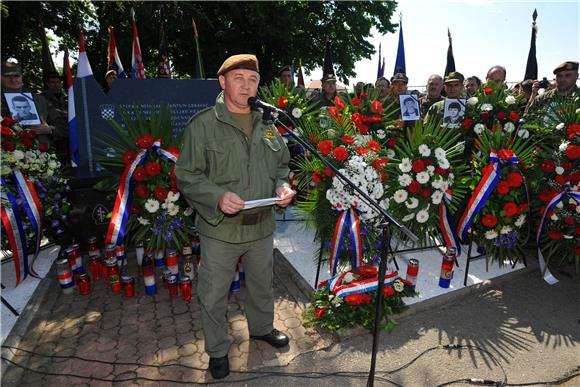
top-left (0, 117), bottom-right (71, 250)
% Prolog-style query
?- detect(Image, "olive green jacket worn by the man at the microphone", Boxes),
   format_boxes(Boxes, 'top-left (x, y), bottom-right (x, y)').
top-left (175, 92), bottom-right (290, 243)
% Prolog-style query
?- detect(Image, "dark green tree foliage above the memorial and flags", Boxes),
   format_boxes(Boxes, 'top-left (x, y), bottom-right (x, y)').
top-left (2, 1), bottom-right (396, 85)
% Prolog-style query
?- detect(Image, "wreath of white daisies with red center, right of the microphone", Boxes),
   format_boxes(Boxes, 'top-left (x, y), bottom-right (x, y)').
top-left (386, 122), bottom-right (467, 244)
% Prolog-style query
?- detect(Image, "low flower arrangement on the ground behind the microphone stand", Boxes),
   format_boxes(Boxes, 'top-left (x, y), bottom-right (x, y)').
top-left (305, 265), bottom-right (416, 332)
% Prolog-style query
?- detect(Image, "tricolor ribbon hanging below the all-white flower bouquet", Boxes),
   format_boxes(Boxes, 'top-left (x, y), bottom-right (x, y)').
top-left (329, 208), bottom-right (362, 276)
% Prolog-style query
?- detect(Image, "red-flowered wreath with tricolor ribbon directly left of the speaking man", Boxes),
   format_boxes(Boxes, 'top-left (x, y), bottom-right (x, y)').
top-left (97, 109), bottom-right (193, 251)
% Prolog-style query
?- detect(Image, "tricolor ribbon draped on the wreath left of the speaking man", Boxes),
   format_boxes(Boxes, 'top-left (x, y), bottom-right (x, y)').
top-left (105, 140), bottom-right (179, 245)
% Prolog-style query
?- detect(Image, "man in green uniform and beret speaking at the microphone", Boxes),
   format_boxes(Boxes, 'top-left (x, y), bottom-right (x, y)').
top-left (175, 54), bottom-right (295, 379)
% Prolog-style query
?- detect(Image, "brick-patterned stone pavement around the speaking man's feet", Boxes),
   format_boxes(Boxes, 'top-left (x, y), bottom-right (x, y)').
top-left (2, 250), bottom-right (332, 386)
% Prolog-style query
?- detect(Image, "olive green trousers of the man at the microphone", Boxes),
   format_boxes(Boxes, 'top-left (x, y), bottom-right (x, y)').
top-left (197, 233), bottom-right (274, 357)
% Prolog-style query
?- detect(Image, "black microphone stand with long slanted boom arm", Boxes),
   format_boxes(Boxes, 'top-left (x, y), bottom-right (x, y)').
top-left (263, 109), bottom-right (419, 387)
